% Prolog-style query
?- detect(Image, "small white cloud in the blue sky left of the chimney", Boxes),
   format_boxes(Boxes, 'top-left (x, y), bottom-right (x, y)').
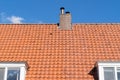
top-left (6, 16), bottom-right (24, 24)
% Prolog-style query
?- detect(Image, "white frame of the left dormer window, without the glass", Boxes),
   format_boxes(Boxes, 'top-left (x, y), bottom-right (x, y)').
top-left (0, 62), bottom-right (27, 80)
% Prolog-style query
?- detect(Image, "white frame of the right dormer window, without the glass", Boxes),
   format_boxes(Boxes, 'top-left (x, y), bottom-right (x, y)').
top-left (97, 61), bottom-right (120, 80)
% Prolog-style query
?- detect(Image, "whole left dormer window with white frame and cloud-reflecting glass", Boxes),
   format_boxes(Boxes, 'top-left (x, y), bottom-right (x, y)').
top-left (0, 62), bottom-right (26, 80)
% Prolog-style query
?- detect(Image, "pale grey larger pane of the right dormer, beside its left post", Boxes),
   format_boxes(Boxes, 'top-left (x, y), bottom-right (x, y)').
top-left (104, 67), bottom-right (115, 80)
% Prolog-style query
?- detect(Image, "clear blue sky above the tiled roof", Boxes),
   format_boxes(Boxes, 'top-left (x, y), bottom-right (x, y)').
top-left (0, 0), bottom-right (120, 23)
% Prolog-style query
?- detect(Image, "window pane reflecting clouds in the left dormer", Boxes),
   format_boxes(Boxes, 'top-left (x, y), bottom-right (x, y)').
top-left (7, 68), bottom-right (20, 80)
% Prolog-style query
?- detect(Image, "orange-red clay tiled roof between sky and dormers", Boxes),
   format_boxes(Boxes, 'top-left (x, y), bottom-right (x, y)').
top-left (0, 24), bottom-right (120, 80)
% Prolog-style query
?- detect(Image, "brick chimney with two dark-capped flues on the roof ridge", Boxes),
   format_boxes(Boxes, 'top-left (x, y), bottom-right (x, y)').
top-left (59, 7), bottom-right (72, 30)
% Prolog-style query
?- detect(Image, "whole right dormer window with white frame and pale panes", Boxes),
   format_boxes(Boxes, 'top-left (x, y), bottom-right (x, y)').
top-left (97, 62), bottom-right (120, 80)
